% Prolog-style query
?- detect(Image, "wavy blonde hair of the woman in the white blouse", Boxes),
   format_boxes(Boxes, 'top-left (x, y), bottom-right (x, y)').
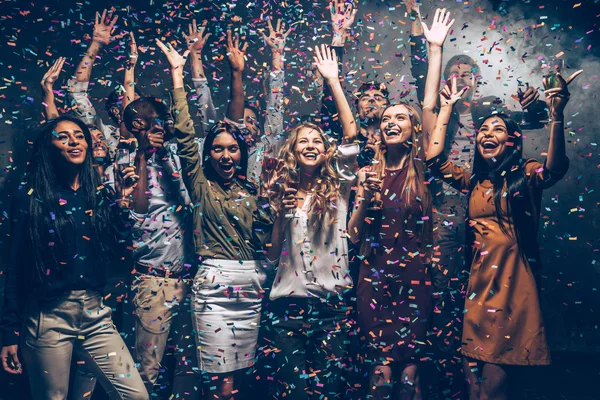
top-left (275, 122), bottom-right (340, 221)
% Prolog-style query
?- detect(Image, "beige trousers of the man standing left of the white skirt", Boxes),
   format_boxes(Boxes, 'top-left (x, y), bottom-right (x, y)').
top-left (131, 274), bottom-right (200, 400)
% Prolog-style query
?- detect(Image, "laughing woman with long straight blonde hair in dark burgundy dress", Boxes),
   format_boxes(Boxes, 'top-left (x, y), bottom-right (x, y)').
top-left (348, 104), bottom-right (433, 399)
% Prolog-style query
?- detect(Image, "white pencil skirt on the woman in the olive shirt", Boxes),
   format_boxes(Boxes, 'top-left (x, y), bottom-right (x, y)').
top-left (192, 260), bottom-right (267, 374)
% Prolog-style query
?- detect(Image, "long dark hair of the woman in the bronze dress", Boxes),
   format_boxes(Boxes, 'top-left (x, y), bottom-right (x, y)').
top-left (467, 113), bottom-right (539, 267)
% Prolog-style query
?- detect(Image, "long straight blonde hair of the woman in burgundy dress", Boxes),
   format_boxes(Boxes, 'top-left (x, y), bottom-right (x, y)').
top-left (360, 103), bottom-right (433, 257)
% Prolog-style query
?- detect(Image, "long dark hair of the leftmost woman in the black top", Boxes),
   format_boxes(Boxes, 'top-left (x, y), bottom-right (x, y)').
top-left (27, 115), bottom-right (115, 280)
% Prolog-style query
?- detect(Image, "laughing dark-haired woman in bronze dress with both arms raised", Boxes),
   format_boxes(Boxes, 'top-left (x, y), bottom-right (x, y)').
top-left (427, 71), bottom-right (581, 399)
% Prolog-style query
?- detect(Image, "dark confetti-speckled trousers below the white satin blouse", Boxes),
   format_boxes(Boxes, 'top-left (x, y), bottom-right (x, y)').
top-left (268, 298), bottom-right (348, 400)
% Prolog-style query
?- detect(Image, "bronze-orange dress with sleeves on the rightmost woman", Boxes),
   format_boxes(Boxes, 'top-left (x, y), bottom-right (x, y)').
top-left (428, 156), bottom-right (566, 365)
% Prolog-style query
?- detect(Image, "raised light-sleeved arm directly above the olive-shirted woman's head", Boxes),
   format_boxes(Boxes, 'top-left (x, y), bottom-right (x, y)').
top-left (183, 19), bottom-right (217, 137)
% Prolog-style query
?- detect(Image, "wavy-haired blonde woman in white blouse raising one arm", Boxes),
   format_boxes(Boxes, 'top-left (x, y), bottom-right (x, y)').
top-left (267, 46), bottom-right (360, 400)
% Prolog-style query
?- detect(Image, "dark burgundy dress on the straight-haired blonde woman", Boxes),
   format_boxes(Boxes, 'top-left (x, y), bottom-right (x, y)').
top-left (357, 167), bottom-right (433, 365)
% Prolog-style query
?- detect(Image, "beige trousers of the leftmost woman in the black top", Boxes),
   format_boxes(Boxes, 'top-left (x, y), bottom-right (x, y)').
top-left (21, 290), bottom-right (148, 400)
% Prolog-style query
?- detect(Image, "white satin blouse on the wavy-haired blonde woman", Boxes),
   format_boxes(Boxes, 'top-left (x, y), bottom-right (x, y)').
top-left (270, 143), bottom-right (360, 300)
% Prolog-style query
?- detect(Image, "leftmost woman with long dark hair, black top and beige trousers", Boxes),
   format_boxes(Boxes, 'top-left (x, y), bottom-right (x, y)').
top-left (0, 116), bottom-right (148, 400)
